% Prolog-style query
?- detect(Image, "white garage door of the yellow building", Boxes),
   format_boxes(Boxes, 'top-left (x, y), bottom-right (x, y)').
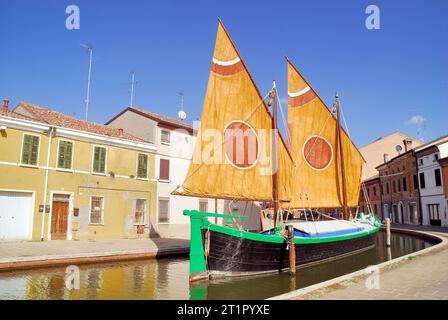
top-left (0, 191), bottom-right (33, 240)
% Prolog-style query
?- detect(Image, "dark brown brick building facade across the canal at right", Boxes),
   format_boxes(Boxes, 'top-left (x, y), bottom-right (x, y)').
top-left (377, 146), bottom-right (422, 224)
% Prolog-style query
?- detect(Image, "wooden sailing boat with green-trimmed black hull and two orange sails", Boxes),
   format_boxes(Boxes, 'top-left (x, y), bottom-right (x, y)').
top-left (173, 21), bottom-right (380, 280)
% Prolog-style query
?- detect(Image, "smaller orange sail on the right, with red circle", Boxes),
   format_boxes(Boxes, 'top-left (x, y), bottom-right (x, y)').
top-left (288, 60), bottom-right (364, 208)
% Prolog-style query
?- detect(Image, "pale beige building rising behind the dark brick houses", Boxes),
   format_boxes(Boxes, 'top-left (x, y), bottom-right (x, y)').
top-left (360, 132), bottom-right (424, 181)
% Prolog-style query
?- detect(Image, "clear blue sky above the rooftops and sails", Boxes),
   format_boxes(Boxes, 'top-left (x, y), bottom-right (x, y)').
top-left (0, 0), bottom-right (448, 146)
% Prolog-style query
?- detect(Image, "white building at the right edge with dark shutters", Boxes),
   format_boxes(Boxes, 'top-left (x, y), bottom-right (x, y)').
top-left (415, 136), bottom-right (448, 227)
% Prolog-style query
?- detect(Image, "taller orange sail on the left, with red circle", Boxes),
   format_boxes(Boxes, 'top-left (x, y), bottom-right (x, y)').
top-left (174, 21), bottom-right (292, 201)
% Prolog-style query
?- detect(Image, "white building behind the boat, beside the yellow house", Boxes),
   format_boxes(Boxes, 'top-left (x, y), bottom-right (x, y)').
top-left (106, 107), bottom-right (260, 238)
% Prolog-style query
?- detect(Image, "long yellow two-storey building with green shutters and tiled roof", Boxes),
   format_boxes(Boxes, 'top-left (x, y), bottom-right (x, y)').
top-left (0, 101), bottom-right (157, 240)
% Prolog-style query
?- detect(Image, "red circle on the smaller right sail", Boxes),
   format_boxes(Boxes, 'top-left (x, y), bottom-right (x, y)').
top-left (302, 136), bottom-right (333, 170)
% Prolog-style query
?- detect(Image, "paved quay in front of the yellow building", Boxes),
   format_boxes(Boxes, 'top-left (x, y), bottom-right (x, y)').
top-left (0, 238), bottom-right (189, 271)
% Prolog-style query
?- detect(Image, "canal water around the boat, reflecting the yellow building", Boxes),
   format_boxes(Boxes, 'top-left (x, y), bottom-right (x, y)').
top-left (0, 232), bottom-right (432, 300)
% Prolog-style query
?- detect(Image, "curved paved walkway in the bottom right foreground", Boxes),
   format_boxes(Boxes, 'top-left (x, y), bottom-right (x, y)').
top-left (291, 225), bottom-right (448, 300)
